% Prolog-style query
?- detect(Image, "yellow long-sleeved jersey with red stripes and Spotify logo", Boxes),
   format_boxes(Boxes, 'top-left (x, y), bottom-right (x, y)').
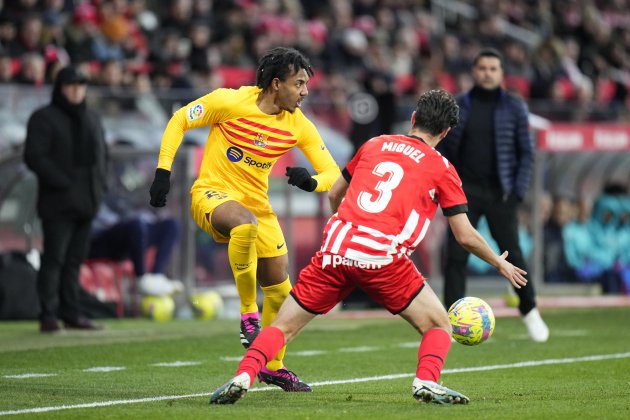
top-left (158, 86), bottom-right (341, 210)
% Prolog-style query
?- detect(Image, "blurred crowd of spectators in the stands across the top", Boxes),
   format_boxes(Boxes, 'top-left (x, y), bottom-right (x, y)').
top-left (0, 0), bottom-right (630, 129)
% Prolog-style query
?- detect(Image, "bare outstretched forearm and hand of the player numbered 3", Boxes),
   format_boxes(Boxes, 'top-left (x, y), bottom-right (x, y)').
top-left (448, 213), bottom-right (527, 288)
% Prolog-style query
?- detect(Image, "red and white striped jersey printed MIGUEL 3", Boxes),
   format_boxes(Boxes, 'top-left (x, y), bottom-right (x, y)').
top-left (321, 135), bottom-right (467, 265)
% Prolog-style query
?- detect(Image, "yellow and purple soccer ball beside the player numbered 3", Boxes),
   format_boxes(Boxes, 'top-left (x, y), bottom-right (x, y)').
top-left (448, 297), bottom-right (494, 346)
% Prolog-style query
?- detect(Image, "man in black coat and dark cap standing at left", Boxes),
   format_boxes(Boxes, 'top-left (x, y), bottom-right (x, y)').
top-left (24, 67), bottom-right (107, 332)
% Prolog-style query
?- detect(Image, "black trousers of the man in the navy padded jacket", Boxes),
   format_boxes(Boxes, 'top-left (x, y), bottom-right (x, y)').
top-left (444, 180), bottom-right (536, 315)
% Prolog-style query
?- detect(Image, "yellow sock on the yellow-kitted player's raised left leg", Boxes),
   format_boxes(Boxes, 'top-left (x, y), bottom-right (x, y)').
top-left (228, 224), bottom-right (258, 314)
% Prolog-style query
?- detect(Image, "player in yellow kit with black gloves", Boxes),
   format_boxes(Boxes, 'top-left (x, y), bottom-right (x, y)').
top-left (150, 47), bottom-right (341, 392)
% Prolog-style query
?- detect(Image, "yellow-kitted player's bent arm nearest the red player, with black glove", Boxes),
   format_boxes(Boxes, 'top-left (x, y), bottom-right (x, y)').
top-left (286, 118), bottom-right (341, 192)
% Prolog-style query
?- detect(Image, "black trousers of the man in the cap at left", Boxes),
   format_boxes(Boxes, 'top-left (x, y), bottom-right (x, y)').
top-left (37, 220), bottom-right (91, 322)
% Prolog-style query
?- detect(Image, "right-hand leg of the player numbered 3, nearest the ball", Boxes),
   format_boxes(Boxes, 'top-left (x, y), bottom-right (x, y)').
top-left (400, 283), bottom-right (469, 404)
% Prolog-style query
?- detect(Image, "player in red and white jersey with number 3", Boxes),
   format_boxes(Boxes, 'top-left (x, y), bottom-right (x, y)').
top-left (210, 90), bottom-right (527, 404)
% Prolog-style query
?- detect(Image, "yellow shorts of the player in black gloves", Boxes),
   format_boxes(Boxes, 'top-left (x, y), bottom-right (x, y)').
top-left (190, 189), bottom-right (287, 258)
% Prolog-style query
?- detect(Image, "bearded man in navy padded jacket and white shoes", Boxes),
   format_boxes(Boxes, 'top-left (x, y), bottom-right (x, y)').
top-left (438, 49), bottom-right (549, 342)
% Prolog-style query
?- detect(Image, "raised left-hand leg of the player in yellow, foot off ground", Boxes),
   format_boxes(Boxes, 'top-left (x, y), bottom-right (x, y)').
top-left (191, 191), bottom-right (260, 347)
